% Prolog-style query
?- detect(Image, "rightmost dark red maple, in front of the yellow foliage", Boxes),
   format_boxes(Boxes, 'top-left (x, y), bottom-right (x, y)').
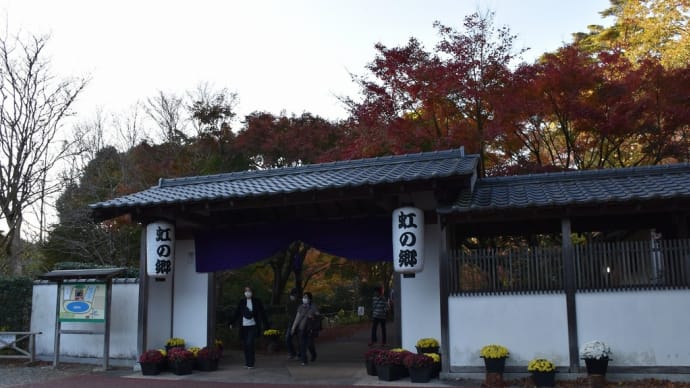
top-left (491, 44), bottom-right (690, 174)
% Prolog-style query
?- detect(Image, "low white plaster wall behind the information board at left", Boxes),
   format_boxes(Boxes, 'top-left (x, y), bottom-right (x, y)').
top-left (31, 282), bottom-right (139, 359)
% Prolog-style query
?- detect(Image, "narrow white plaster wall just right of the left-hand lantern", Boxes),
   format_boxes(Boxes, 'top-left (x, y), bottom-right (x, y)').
top-left (173, 240), bottom-right (211, 347)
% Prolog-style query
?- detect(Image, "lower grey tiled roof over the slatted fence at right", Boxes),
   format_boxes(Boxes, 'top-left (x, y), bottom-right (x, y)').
top-left (438, 164), bottom-right (690, 214)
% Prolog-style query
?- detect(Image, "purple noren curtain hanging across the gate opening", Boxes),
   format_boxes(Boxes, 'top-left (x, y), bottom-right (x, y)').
top-left (194, 218), bottom-right (393, 272)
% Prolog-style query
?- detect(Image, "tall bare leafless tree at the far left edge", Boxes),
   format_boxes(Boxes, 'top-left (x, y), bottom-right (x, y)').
top-left (0, 36), bottom-right (87, 275)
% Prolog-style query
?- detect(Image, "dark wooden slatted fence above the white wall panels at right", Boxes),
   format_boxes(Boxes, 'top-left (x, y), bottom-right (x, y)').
top-left (450, 240), bottom-right (690, 295)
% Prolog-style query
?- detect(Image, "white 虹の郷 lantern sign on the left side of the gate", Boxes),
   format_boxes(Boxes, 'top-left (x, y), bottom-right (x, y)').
top-left (146, 221), bottom-right (175, 277)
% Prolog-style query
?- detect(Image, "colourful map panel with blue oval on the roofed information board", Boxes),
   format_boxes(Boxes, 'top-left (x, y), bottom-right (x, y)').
top-left (59, 283), bottom-right (107, 322)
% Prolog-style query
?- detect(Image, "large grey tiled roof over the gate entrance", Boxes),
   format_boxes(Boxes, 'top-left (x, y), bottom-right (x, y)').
top-left (89, 149), bottom-right (478, 209)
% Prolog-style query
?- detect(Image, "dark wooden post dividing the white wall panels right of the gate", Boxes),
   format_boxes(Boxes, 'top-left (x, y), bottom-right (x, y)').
top-left (561, 218), bottom-right (580, 373)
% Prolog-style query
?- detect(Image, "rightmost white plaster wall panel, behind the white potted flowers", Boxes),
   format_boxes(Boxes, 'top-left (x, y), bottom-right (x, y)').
top-left (576, 290), bottom-right (690, 366)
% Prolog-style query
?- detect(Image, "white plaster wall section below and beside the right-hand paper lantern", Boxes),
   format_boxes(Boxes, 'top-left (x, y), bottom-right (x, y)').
top-left (396, 225), bottom-right (441, 351)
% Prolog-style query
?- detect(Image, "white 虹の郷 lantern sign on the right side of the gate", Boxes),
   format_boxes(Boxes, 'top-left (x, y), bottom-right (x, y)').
top-left (393, 206), bottom-right (424, 273)
